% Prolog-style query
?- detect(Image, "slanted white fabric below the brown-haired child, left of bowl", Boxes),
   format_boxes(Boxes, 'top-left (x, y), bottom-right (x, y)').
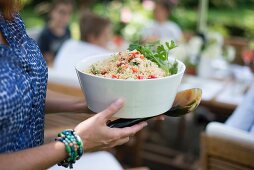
top-left (48, 40), bottom-right (109, 87)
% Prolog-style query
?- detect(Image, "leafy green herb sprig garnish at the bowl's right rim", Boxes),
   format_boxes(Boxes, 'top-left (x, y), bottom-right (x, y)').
top-left (128, 41), bottom-right (178, 75)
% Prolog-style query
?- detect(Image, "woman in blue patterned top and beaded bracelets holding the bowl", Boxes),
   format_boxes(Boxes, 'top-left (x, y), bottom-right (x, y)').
top-left (0, 0), bottom-right (153, 169)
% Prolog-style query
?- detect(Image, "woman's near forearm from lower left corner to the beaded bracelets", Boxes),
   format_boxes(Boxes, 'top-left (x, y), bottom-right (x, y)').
top-left (0, 142), bottom-right (67, 170)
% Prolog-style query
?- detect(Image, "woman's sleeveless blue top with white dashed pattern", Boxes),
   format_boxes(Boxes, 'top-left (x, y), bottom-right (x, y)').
top-left (0, 13), bottom-right (47, 153)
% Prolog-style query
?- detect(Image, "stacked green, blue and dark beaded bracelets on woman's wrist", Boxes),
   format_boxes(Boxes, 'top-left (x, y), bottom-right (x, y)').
top-left (55, 129), bottom-right (83, 169)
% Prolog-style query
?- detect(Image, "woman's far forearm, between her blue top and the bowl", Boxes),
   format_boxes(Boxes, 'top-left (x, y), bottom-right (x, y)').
top-left (45, 90), bottom-right (91, 113)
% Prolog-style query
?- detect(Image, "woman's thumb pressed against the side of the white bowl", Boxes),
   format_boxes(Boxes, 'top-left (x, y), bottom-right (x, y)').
top-left (99, 98), bottom-right (124, 121)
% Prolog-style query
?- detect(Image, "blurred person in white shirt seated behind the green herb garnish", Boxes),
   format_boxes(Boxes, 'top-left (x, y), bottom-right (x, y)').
top-left (141, 0), bottom-right (183, 42)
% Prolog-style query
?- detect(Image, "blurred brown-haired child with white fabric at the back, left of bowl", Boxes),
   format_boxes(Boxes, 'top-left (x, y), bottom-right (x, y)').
top-left (53, 12), bottom-right (112, 78)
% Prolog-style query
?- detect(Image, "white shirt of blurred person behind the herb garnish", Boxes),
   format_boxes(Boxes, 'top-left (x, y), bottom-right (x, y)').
top-left (141, 21), bottom-right (182, 42)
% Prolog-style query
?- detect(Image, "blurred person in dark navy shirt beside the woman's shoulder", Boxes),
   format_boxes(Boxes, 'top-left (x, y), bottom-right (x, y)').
top-left (38, 0), bottom-right (74, 66)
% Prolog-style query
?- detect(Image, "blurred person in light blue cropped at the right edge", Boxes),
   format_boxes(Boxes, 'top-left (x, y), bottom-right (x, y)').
top-left (225, 83), bottom-right (254, 134)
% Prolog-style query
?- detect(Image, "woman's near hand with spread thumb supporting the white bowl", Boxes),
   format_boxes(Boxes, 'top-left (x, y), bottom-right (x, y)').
top-left (75, 99), bottom-right (147, 151)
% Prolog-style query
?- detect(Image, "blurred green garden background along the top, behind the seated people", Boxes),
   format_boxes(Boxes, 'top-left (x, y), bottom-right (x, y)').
top-left (21, 0), bottom-right (254, 40)
